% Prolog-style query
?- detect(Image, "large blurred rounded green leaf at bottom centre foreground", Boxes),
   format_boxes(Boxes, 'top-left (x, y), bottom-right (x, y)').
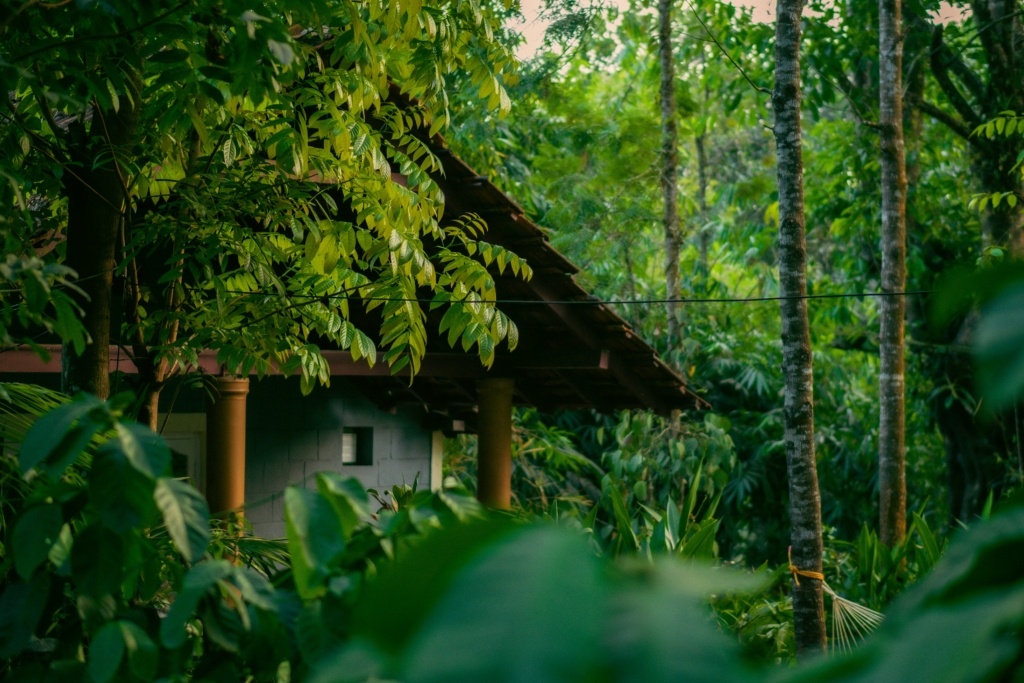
top-left (401, 526), bottom-right (607, 683)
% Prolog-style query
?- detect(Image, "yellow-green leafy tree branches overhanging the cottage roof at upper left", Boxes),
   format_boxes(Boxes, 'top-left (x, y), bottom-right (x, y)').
top-left (0, 0), bottom-right (530, 390)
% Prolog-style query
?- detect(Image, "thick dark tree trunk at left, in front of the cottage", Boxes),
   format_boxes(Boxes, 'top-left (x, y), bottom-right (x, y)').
top-left (60, 98), bottom-right (138, 399)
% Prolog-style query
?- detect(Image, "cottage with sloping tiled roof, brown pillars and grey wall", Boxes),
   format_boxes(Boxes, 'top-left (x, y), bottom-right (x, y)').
top-left (0, 113), bottom-right (700, 538)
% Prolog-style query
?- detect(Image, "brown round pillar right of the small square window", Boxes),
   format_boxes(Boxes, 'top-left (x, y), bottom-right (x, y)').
top-left (476, 378), bottom-right (515, 510)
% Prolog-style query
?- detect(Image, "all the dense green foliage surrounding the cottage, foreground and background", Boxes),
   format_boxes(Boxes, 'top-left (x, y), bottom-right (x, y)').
top-left (0, 0), bottom-right (1024, 683)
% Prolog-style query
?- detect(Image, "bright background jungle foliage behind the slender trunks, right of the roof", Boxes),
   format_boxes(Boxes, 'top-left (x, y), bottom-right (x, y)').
top-left (451, 2), bottom-right (1024, 565)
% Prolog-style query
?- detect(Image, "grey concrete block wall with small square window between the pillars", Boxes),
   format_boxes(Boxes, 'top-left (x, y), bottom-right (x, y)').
top-left (246, 377), bottom-right (439, 539)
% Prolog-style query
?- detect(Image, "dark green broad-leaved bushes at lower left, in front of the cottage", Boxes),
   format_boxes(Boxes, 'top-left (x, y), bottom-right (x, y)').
top-left (0, 384), bottom-right (479, 683)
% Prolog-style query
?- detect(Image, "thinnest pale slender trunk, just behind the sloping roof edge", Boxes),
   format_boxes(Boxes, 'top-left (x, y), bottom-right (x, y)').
top-left (657, 0), bottom-right (680, 346)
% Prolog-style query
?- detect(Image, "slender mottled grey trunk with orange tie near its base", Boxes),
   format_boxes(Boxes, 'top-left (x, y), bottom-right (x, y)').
top-left (771, 0), bottom-right (825, 655)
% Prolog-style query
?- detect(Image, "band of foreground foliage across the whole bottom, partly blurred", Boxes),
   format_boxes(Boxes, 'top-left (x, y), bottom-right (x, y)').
top-left (6, 385), bottom-right (1024, 682)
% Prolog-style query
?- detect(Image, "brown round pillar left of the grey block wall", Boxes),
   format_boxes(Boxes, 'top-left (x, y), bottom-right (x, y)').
top-left (206, 377), bottom-right (249, 514)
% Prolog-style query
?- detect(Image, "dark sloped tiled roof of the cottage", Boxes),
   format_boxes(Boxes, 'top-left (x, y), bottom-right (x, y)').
top-left (344, 90), bottom-right (703, 417)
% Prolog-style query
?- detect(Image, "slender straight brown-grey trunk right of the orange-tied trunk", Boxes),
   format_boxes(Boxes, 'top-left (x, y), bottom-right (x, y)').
top-left (879, 0), bottom-right (906, 548)
